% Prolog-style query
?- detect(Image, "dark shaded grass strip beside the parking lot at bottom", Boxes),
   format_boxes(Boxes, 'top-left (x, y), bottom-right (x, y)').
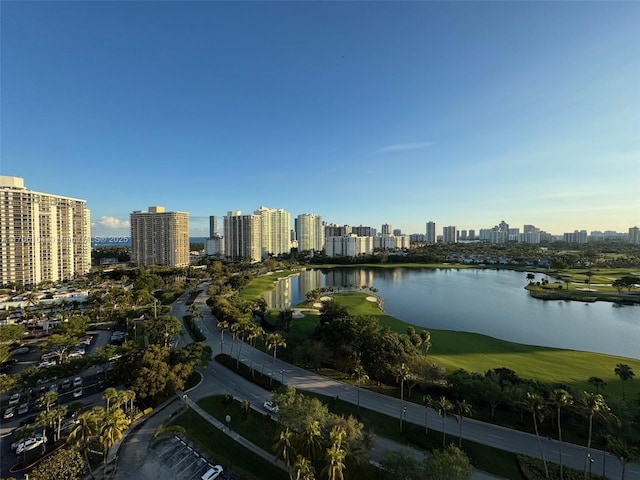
top-left (171, 409), bottom-right (289, 480)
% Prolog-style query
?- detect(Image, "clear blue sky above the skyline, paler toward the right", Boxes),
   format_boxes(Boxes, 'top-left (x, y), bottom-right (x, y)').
top-left (0, 0), bottom-right (640, 235)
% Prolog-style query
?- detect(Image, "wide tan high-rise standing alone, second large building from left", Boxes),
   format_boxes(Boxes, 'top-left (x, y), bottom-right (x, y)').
top-left (131, 206), bottom-right (189, 267)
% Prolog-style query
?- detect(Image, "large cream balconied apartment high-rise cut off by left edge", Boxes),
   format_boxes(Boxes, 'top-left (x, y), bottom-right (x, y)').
top-left (0, 176), bottom-right (91, 285)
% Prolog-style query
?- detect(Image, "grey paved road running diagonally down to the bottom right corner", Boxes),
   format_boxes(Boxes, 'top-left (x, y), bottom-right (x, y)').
top-left (182, 284), bottom-right (640, 480)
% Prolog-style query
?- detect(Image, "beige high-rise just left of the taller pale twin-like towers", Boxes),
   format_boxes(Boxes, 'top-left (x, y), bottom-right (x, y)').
top-left (224, 210), bottom-right (262, 262)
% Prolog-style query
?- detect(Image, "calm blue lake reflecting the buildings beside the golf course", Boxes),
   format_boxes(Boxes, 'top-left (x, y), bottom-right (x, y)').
top-left (265, 268), bottom-right (640, 358)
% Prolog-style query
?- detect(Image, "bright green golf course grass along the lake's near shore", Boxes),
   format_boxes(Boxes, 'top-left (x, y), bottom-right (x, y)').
top-left (292, 292), bottom-right (640, 398)
